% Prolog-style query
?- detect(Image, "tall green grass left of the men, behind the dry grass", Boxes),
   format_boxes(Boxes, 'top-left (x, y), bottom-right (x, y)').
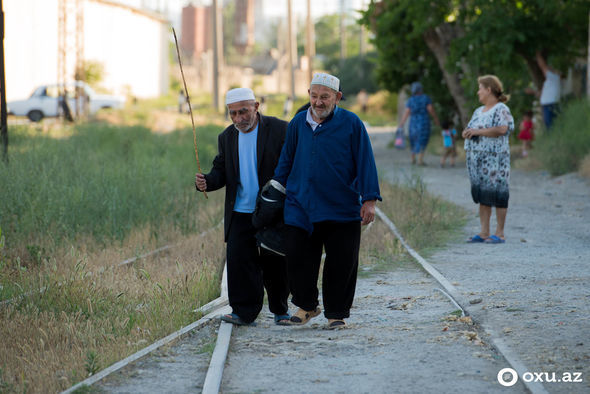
top-left (0, 124), bottom-right (219, 255)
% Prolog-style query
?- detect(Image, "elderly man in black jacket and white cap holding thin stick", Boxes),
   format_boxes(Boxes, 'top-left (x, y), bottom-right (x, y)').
top-left (195, 88), bottom-right (290, 325)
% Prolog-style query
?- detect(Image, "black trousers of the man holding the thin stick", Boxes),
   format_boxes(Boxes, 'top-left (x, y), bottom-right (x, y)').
top-left (227, 212), bottom-right (289, 323)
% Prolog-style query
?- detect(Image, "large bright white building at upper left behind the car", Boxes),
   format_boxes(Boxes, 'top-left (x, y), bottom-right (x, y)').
top-left (3, 0), bottom-right (171, 101)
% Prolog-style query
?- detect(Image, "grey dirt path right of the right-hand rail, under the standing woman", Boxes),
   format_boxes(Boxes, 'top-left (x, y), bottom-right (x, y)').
top-left (372, 127), bottom-right (590, 393)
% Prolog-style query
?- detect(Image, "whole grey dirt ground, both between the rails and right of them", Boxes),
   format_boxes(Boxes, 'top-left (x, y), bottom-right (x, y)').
top-left (95, 127), bottom-right (590, 393)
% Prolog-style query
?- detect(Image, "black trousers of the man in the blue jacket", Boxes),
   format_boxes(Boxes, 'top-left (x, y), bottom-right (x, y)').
top-left (286, 222), bottom-right (361, 319)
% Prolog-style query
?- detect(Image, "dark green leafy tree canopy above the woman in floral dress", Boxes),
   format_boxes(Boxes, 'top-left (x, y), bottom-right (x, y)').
top-left (362, 0), bottom-right (590, 124)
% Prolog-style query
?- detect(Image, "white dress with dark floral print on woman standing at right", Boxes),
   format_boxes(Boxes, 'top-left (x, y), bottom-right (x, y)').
top-left (465, 103), bottom-right (514, 208)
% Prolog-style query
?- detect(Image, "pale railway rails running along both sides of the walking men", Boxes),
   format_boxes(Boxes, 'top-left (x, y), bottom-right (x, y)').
top-left (64, 209), bottom-right (547, 394)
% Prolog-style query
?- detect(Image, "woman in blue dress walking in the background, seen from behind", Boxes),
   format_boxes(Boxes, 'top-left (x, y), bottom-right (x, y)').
top-left (399, 82), bottom-right (440, 166)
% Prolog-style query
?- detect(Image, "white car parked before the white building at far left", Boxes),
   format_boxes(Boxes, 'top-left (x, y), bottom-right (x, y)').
top-left (7, 81), bottom-right (125, 122)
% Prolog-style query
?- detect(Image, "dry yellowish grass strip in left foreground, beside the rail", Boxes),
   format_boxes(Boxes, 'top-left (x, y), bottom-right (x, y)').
top-left (0, 222), bottom-right (225, 392)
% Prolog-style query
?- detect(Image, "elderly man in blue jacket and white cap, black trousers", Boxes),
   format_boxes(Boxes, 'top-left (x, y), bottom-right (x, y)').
top-left (273, 73), bottom-right (381, 329)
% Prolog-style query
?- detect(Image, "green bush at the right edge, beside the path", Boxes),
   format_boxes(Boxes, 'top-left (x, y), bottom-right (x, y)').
top-left (531, 100), bottom-right (590, 175)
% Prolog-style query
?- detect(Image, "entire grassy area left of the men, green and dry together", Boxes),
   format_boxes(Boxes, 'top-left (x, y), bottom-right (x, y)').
top-left (0, 124), bottom-right (224, 392)
